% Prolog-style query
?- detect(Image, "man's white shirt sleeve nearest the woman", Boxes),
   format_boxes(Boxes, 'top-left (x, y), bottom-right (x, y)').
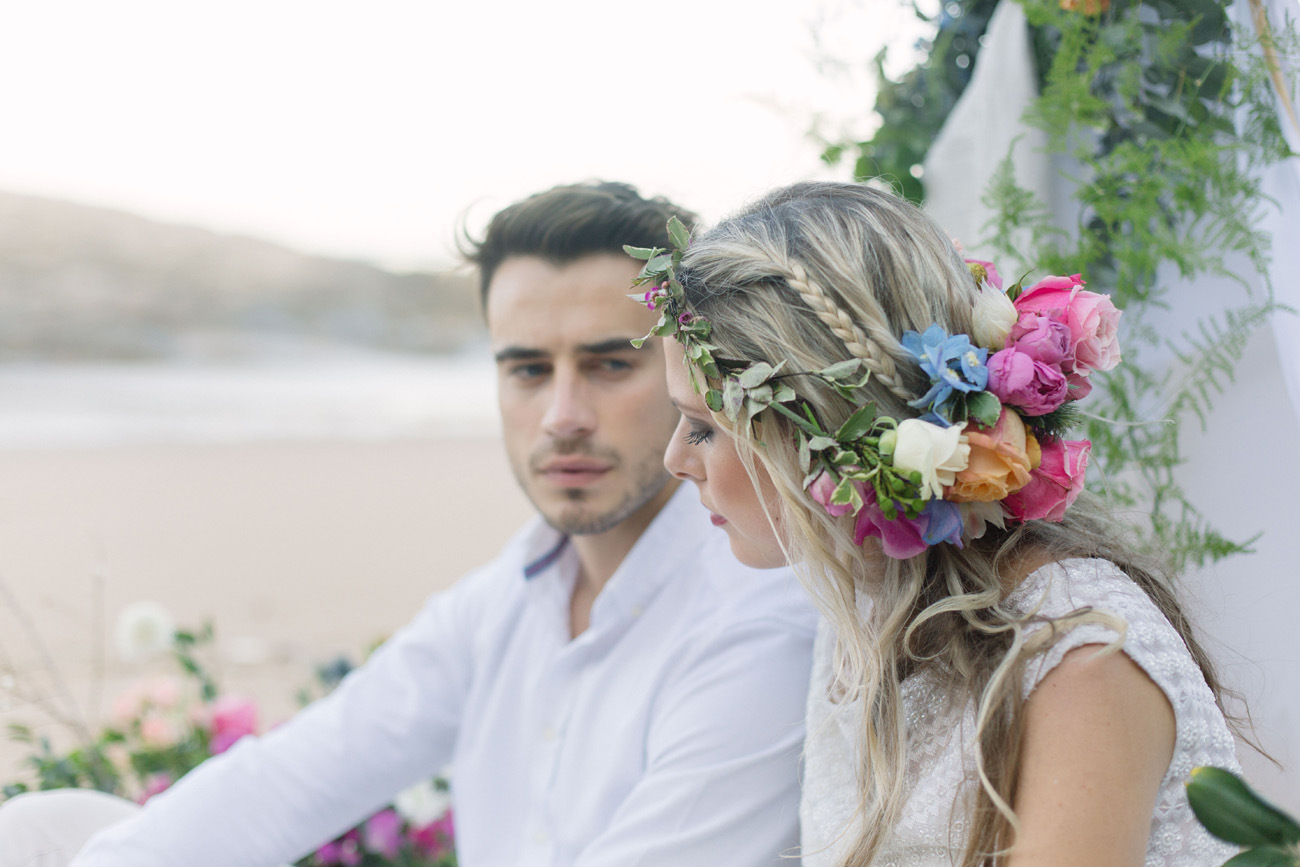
top-left (575, 617), bottom-right (813, 867)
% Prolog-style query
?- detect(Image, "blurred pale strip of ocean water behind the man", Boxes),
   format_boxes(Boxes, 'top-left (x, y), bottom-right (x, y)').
top-left (0, 348), bottom-right (501, 448)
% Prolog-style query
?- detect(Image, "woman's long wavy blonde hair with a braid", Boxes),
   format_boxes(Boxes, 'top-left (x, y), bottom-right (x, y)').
top-left (679, 182), bottom-right (1222, 867)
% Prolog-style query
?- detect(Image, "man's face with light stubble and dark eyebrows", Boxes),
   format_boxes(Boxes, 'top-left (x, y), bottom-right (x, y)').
top-left (488, 253), bottom-right (677, 534)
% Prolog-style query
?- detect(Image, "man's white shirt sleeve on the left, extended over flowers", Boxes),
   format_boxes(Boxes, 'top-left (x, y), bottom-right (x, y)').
top-left (73, 573), bottom-right (490, 867)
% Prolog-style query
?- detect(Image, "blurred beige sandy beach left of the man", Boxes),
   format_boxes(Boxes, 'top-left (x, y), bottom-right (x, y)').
top-left (0, 437), bottom-right (530, 783)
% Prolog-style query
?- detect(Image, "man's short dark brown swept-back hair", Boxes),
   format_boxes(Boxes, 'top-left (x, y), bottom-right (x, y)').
top-left (462, 181), bottom-right (698, 308)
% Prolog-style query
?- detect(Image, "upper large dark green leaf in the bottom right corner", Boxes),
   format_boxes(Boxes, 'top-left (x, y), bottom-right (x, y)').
top-left (1187, 767), bottom-right (1300, 846)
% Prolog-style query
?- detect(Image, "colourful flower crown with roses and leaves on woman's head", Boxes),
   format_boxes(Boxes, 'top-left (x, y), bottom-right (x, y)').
top-left (624, 217), bottom-right (1121, 559)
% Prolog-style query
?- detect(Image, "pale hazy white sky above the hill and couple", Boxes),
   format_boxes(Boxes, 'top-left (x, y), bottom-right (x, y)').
top-left (0, 0), bottom-right (915, 266)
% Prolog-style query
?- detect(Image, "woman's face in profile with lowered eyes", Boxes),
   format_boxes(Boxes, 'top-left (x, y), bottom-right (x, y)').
top-left (663, 338), bottom-right (785, 569)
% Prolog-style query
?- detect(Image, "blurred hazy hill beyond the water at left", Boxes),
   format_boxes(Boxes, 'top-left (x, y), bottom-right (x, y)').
top-left (0, 192), bottom-right (485, 360)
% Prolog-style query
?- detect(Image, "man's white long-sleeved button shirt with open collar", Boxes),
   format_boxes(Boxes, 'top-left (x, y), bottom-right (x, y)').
top-left (74, 486), bottom-right (815, 867)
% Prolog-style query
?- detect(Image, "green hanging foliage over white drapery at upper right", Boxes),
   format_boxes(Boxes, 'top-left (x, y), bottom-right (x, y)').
top-left (826, 0), bottom-right (1300, 565)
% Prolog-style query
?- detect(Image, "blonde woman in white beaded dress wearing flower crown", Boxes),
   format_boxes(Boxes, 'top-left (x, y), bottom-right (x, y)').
top-left (647, 183), bottom-right (1235, 867)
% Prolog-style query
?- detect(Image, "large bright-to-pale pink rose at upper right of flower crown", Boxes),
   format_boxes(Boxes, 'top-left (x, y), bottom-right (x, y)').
top-left (1015, 274), bottom-right (1121, 376)
